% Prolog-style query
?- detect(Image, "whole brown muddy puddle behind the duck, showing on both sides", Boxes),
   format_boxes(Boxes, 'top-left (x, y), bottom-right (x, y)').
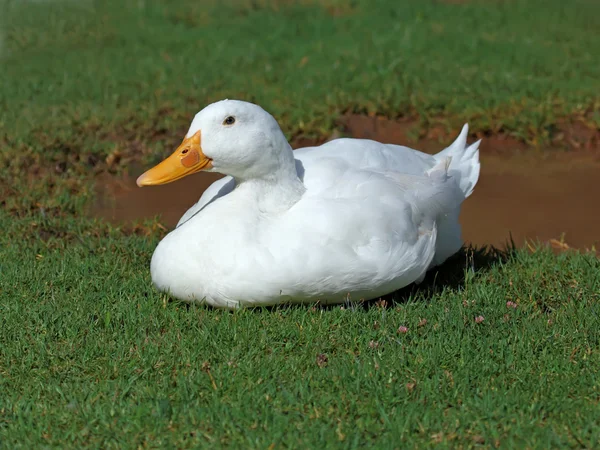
top-left (93, 118), bottom-right (600, 249)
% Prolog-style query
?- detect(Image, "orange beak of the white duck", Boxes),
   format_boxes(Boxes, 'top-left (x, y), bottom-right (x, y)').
top-left (136, 131), bottom-right (212, 187)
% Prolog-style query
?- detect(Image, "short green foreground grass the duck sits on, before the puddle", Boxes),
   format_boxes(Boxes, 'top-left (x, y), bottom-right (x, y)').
top-left (0, 224), bottom-right (600, 448)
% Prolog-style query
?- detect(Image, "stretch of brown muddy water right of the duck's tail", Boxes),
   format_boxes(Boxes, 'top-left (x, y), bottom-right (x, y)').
top-left (461, 155), bottom-right (600, 249)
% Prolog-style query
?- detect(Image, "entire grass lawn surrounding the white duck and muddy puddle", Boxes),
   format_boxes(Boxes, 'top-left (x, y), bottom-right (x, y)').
top-left (0, 0), bottom-right (600, 448)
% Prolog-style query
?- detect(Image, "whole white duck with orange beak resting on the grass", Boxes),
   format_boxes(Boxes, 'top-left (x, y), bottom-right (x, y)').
top-left (137, 100), bottom-right (479, 308)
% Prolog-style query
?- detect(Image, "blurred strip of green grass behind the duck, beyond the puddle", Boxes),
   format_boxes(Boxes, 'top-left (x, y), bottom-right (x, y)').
top-left (0, 0), bottom-right (600, 140)
